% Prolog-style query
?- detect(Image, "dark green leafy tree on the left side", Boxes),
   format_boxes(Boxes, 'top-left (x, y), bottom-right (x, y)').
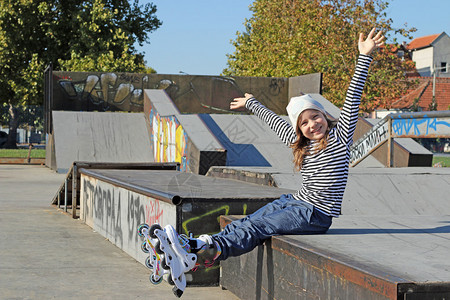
top-left (0, 0), bottom-right (161, 147)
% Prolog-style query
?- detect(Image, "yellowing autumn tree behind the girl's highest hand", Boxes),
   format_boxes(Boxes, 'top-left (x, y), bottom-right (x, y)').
top-left (223, 0), bottom-right (415, 111)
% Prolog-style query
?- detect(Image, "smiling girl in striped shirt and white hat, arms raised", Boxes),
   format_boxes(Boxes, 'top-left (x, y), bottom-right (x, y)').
top-left (149, 28), bottom-right (384, 292)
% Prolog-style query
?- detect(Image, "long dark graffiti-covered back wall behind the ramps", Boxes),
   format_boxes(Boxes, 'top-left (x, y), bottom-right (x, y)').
top-left (49, 71), bottom-right (289, 114)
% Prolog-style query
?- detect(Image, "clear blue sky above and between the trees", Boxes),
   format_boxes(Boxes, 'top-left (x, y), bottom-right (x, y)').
top-left (138, 0), bottom-right (450, 75)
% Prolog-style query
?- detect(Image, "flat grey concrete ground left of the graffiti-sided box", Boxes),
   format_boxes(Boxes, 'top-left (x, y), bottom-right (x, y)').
top-left (0, 165), bottom-right (238, 299)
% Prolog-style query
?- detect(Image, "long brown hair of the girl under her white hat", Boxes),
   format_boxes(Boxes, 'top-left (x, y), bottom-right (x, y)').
top-left (291, 114), bottom-right (336, 171)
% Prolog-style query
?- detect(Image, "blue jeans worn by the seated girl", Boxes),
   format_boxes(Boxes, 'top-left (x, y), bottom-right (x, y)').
top-left (212, 194), bottom-right (332, 260)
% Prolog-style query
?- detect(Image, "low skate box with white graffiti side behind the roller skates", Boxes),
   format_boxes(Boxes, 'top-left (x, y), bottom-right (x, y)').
top-left (80, 169), bottom-right (292, 286)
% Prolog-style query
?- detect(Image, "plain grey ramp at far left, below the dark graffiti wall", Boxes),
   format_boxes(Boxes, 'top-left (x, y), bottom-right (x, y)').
top-left (47, 111), bottom-right (153, 173)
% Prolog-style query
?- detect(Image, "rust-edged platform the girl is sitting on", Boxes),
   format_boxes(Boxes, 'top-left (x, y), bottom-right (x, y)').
top-left (220, 216), bottom-right (450, 299)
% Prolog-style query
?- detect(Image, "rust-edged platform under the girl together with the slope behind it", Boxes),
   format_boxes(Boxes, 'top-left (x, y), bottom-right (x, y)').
top-left (221, 167), bottom-right (450, 299)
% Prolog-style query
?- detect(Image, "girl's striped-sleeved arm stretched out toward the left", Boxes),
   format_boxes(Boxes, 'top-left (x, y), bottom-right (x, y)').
top-left (230, 93), bottom-right (297, 146)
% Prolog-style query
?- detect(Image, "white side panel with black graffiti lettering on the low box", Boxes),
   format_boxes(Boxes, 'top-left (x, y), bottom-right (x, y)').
top-left (80, 175), bottom-right (176, 264)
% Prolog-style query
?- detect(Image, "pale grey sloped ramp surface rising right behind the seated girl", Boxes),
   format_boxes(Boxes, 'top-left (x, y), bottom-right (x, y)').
top-left (208, 167), bottom-right (450, 216)
